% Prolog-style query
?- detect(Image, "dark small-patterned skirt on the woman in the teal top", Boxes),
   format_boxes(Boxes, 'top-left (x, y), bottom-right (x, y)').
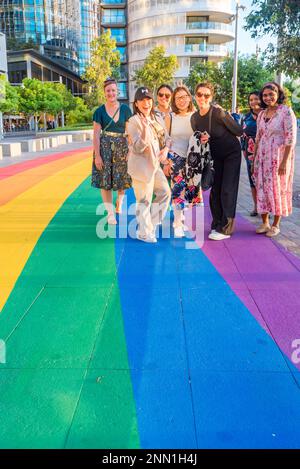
top-left (91, 135), bottom-right (131, 191)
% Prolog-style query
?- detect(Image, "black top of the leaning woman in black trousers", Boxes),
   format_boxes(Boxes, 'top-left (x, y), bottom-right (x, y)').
top-left (191, 106), bottom-right (243, 158)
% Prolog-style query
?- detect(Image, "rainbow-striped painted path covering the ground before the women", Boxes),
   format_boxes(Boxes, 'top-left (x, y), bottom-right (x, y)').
top-left (0, 149), bottom-right (300, 448)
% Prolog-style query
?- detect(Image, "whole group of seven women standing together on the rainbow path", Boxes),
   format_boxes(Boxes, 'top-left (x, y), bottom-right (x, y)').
top-left (92, 79), bottom-right (296, 243)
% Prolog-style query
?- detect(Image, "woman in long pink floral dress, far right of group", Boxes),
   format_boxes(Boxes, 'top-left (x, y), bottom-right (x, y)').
top-left (253, 82), bottom-right (297, 238)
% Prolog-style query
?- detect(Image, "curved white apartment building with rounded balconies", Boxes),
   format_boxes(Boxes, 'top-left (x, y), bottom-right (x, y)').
top-left (128, 0), bottom-right (235, 100)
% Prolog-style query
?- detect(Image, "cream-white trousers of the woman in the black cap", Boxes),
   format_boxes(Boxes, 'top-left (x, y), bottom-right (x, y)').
top-left (132, 167), bottom-right (171, 237)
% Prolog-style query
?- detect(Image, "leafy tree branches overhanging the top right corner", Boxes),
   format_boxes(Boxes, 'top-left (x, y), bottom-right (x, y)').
top-left (245, 0), bottom-right (300, 77)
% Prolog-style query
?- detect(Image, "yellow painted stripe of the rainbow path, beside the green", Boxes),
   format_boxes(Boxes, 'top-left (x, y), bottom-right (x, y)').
top-left (0, 158), bottom-right (91, 311)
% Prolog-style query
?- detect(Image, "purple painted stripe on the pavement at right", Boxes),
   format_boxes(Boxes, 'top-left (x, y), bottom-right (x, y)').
top-left (186, 197), bottom-right (300, 369)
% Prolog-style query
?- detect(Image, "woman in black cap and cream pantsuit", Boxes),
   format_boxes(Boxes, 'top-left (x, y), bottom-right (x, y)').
top-left (127, 87), bottom-right (171, 243)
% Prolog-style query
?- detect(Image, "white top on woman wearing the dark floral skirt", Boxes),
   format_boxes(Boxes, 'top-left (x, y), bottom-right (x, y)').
top-left (171, 112), bottom-right (194, 158)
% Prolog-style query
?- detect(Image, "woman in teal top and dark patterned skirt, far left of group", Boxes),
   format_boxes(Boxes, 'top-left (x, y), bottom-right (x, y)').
top-left (92, 78), bottom-right (132, 225)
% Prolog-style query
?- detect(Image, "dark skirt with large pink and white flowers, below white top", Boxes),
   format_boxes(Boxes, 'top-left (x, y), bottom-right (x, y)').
top-left (169, 152), bottom-right (202, 208)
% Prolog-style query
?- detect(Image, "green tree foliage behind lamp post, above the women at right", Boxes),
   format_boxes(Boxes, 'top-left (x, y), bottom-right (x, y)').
top-left (186, 55), bottom-right (273, 109)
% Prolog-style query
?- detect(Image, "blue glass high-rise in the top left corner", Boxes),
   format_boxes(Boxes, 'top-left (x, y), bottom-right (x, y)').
top-left (0, 0), bottom-right (80, 72)
